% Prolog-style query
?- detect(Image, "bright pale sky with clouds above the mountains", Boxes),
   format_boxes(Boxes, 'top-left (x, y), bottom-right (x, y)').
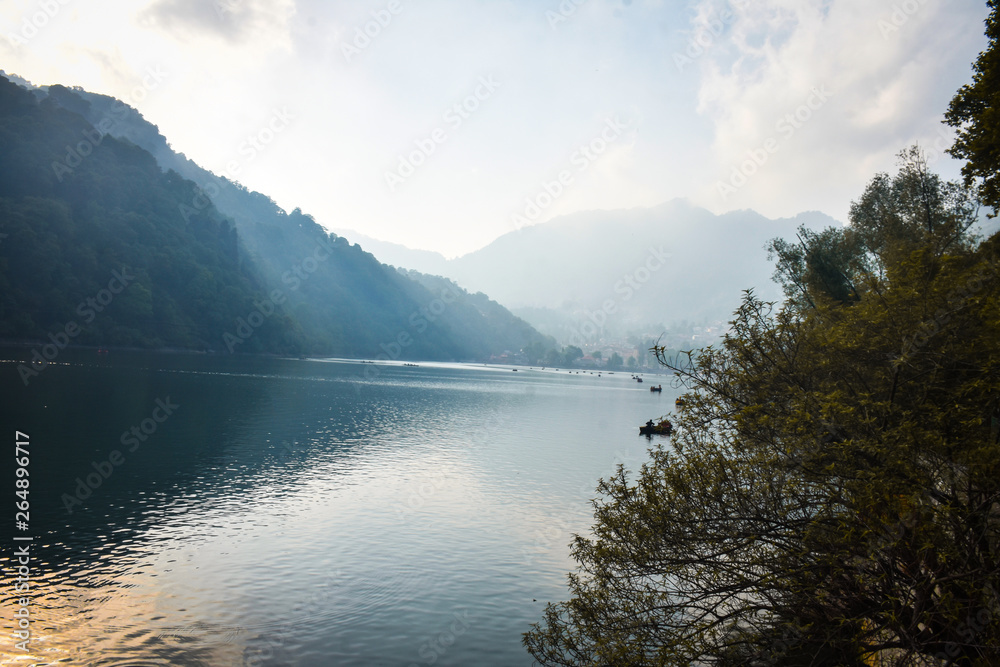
top-left (0, 0), bottom-right (988, 257)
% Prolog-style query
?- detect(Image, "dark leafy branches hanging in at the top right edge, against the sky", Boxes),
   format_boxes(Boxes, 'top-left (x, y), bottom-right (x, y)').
top-left (945, 0), bottom-right (1000, 215)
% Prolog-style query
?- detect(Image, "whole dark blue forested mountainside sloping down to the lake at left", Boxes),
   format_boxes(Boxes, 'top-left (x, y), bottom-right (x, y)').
top-left (0, 78), bottom-right (552, 360)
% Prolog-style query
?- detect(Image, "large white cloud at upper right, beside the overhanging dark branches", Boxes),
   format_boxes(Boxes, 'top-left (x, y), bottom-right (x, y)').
top-left (697, 0), bottom-right (986, 222)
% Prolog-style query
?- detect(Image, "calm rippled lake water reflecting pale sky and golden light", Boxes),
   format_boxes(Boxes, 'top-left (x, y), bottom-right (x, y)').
top-left (0, 349), bottom-right (678, 667)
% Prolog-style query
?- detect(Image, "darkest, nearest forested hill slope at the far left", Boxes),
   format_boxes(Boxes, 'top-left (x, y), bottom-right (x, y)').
top-left (0, 78), bottom-right (296, 352)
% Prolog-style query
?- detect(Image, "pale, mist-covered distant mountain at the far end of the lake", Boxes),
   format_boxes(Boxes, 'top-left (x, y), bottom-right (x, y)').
top-left (342, 200), bottom-right (841, 344)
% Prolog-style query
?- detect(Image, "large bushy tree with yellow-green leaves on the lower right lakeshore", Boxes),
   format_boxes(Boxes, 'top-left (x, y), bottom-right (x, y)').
top-left (524, 159), bottom-right (1000, 665)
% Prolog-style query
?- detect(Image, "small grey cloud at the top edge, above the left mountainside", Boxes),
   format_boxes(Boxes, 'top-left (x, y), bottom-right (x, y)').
top-left (139, 0), bottom-right (295, 49)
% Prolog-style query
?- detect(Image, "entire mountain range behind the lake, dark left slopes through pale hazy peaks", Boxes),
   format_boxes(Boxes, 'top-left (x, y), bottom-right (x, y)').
top-left (15, 72), bottom-right (952, 360)
